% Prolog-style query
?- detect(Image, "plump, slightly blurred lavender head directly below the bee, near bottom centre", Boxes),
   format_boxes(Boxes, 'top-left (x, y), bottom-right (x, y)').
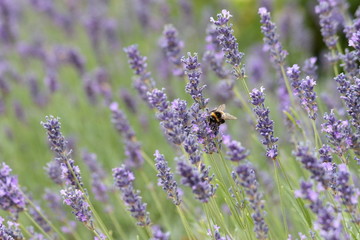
top-left (177, 161), bottom-right (217, 203)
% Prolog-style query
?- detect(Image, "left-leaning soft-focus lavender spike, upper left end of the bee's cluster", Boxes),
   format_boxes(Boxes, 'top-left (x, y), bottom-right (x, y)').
top-left (124, 45), bottom-right (155, 102)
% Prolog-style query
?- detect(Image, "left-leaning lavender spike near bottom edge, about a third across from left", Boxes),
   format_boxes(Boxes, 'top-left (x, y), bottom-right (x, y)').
top-left (113, 165), bottom-right (150, 226)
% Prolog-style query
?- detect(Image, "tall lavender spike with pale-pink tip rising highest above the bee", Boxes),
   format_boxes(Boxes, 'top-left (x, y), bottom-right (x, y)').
top-left (210, 9), bottom-right (244, 71)
